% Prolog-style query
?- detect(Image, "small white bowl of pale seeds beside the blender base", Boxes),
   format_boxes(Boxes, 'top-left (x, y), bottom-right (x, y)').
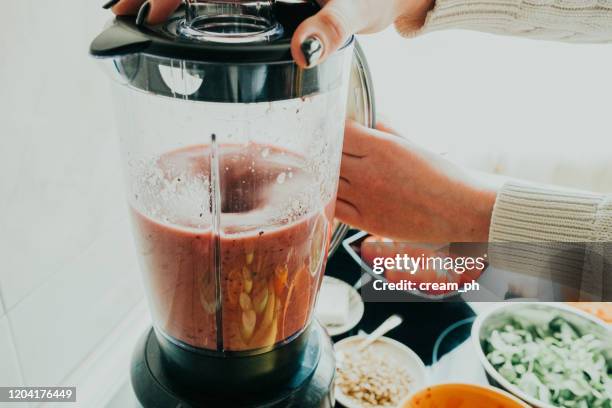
top-left (334, 336), bottom-right (426, 408)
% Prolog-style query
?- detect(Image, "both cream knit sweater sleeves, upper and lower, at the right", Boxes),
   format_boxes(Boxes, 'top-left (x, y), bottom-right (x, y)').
top-left (396, 0), bottom-right (612, 300)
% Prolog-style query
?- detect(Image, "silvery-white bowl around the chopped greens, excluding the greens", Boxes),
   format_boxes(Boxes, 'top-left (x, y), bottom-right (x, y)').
top-left (471, 303), bottom-right (612, 408)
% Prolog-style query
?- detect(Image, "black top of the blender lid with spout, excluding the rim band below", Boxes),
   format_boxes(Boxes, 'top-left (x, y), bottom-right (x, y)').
top-left (90, 0), bottom-right (319, 63)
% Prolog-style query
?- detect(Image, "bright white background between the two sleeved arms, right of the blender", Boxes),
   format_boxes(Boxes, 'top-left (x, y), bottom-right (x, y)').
top-left (361, 30), bottom-right (612, 192)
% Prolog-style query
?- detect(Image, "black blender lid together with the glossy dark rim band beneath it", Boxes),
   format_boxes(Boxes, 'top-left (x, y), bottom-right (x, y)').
top-left (90, 0), bottom-right (354, 103)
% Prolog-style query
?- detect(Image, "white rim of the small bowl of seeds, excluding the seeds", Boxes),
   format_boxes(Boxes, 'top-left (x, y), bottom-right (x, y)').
top-left (334, 335), bottom-right (427, 408)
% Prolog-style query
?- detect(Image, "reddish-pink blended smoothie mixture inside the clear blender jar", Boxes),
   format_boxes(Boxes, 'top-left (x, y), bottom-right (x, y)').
top-left (132, 144), bottom-right (334, 350)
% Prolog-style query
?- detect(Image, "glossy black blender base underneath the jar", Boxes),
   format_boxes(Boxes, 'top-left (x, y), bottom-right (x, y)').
top-left (131, 320), bottom-right (335, 408)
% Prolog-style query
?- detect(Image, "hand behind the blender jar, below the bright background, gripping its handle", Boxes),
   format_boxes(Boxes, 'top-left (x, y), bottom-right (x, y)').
top-left (336, 122), bottom-right (496, 243)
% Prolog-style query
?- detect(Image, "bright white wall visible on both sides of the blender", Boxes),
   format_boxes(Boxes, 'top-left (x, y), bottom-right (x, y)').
top-left (0, 0), bottom-right (612, 402)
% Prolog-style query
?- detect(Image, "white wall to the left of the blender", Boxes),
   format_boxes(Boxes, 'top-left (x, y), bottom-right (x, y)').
top-left (0, 0), bottom-right (142, 396)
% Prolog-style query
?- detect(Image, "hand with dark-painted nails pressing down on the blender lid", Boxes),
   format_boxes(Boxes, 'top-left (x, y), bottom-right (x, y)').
top-left (104, 0), bottom-right (434, 67)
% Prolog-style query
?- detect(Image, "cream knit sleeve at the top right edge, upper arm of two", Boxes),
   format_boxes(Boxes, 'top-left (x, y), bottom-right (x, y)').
top-left (396, 0), bottom-right (612, 43)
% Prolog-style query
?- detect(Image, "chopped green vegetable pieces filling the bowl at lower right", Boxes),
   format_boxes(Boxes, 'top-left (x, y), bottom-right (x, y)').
top-left (483, 316), bottom-right (612, 408)
